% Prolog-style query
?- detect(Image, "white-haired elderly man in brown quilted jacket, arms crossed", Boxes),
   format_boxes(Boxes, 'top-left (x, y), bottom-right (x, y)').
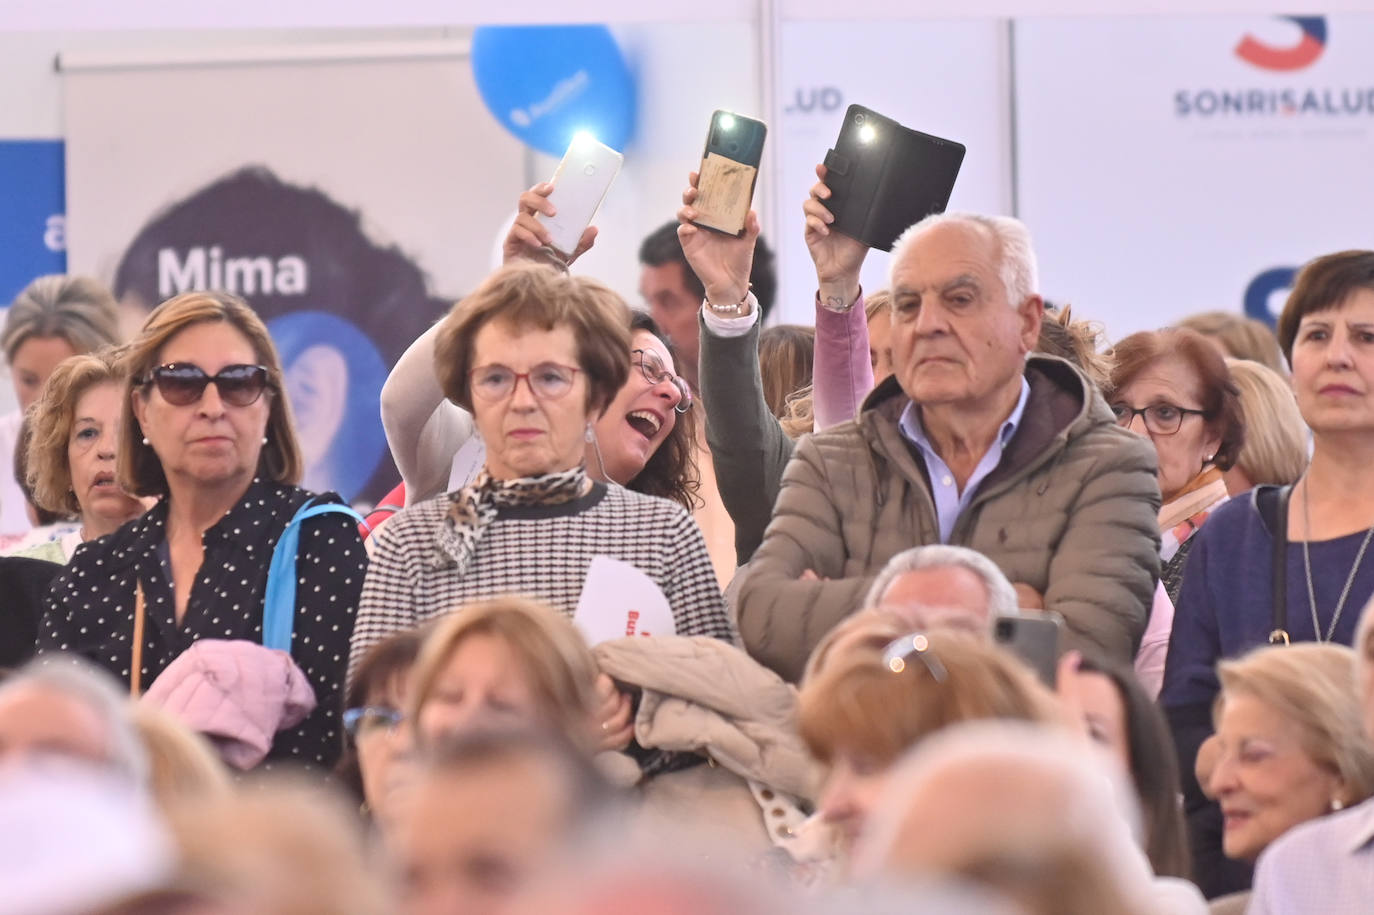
top-left (732, 204), bottom-right (1160, 679)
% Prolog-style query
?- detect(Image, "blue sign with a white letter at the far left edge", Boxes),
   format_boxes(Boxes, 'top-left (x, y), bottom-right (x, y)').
top-left (0, 140), bottom-right (67, 305)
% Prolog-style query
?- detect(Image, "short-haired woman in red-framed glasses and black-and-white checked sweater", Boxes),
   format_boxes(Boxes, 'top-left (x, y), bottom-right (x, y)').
top-left (352, 262), bottom-right (735, 681)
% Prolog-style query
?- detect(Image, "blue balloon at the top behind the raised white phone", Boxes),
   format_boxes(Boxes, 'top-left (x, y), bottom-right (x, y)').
top-left (473, 25), bottom-right (635, 155)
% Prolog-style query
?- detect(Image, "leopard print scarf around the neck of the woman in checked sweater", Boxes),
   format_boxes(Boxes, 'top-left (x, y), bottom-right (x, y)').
top-left (438, 467), bottom-right (587, 574)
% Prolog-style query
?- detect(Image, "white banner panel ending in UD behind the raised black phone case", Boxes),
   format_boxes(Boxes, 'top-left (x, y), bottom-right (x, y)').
top-left (780, 19), bottom-right (1011, 324)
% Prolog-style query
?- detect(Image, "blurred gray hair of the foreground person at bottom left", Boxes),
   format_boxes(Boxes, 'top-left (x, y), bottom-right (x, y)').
top-left (0, 653), bottom-right (151, 786)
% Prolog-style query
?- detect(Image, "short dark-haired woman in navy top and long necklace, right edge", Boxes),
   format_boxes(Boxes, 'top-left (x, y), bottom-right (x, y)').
top-left (1160, 250), bottom-right (1374, 896)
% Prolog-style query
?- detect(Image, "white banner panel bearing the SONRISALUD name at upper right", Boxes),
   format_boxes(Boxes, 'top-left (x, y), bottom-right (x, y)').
top-left (1014, 15), bottom-right (1374, 338)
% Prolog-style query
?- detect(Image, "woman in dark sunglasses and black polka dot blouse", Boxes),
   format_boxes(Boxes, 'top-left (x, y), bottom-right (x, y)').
top-left (38, 293), bottom-right (367, 768)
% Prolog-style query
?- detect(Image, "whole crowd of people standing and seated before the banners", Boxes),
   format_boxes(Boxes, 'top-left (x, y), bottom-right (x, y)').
top-left (0, 158), bottom-right (1374, 915)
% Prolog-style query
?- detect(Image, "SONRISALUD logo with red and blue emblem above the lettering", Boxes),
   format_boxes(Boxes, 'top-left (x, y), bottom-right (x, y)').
top-left (1173, 16), bottom-right (1374, 121)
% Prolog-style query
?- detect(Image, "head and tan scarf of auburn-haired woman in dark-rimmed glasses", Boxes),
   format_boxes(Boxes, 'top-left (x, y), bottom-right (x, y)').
top-left (1107, 327), bottom-right (1245, 602)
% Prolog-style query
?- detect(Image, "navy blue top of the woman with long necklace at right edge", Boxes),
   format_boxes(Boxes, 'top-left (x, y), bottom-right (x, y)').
top-left (1160, 492), bottom-right (1374, 708)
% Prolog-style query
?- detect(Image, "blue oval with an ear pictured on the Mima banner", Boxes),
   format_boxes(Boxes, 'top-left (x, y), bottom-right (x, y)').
top-left (267, 310), bottom-right (387, 500)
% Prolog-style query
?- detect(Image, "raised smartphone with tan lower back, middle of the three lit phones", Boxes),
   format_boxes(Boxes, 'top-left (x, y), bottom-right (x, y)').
top-left (692, 111), bottom-right (768, 236)
